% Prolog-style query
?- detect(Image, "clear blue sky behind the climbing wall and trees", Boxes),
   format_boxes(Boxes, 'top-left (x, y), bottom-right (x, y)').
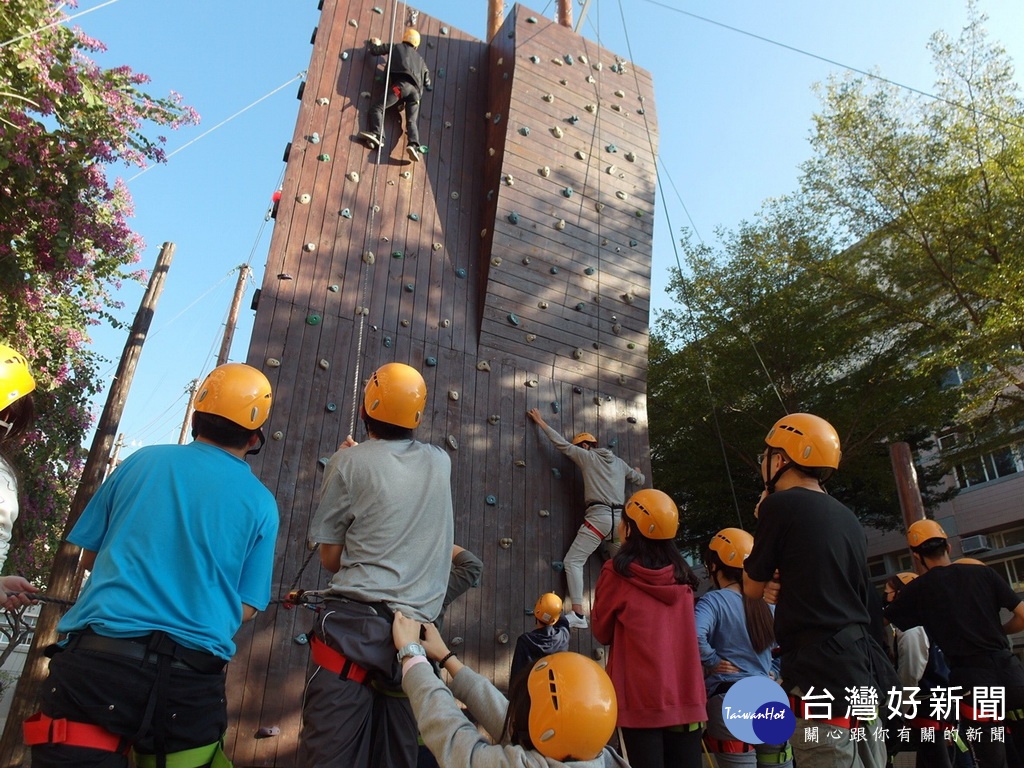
top-left (73, 0), bottom-right (1024, 453)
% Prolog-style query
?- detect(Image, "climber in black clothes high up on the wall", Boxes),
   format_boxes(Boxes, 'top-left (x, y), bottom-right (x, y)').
top-left (359, 29), bottom-right (432, 163)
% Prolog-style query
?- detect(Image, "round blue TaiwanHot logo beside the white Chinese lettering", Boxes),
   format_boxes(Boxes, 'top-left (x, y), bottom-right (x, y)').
top-left (722, 677), bottom-right (797, 744)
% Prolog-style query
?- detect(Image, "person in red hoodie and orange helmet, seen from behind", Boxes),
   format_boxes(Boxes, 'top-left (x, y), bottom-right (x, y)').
top-left (591, 488), bottom-right (707, 768)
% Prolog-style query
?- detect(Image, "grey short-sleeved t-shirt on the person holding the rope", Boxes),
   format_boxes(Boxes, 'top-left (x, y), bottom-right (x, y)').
top-left (309, 439), bottom-right (455, 622)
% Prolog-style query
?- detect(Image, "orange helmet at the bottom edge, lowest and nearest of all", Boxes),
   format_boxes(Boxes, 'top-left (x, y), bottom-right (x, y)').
top-left (526, 651), bottom-right (618, 762)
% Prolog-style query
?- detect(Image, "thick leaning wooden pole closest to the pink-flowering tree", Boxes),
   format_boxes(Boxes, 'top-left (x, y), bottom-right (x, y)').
top-left (0, 243), bottom-right (174, 768)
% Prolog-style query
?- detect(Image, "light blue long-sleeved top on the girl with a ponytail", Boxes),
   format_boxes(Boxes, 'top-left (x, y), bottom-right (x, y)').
top-left (695, 589), bottom-right (778, 696)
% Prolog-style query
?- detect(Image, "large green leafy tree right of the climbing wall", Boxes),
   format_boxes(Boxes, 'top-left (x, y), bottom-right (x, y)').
top-left (650, 5), bottom-right (1024, 548)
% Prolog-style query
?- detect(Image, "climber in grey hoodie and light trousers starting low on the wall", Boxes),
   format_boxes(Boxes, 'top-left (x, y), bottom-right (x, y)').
top-left (526, 408), bottom-right (644, 630)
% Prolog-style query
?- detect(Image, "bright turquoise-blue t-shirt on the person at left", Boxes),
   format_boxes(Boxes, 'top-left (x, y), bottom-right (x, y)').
top-left (57, 442), bottom-right (278, 659)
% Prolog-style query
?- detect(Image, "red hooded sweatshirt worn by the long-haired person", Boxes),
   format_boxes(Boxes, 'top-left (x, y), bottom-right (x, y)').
top-left (590, 560), bottom-right (708, 728)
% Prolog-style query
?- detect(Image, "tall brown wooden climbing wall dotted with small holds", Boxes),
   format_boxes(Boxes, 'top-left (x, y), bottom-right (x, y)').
top-left (227, 0), bottom-right (657, 766)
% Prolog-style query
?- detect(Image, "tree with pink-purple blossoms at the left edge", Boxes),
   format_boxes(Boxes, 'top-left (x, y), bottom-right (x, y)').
top-left (0, 0), bottom-right (198, 578)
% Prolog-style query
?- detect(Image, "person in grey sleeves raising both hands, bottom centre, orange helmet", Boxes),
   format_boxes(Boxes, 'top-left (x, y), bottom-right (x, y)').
top-left (391, 611), bottom-right (629, 768)
